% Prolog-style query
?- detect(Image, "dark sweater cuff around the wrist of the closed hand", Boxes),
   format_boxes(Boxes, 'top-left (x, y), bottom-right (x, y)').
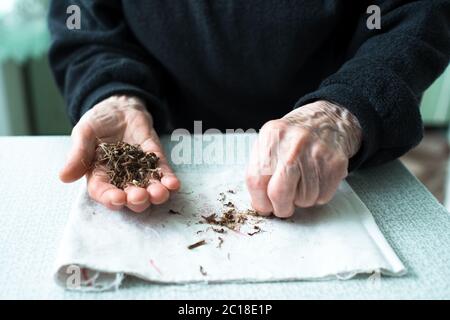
top-left (295, 83), bottom-right (381, 172)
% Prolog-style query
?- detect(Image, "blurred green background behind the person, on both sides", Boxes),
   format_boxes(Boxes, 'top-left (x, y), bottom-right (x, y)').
top-left (0, 0), bottom-right (450, 208)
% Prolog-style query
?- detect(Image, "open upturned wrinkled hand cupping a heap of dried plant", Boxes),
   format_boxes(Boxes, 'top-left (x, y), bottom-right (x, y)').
top-left (60, 96), bottom-right (180, 212)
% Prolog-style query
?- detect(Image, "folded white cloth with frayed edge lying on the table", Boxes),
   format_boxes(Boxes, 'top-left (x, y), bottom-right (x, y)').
top-left (55, 168), bottom-right (405, 290)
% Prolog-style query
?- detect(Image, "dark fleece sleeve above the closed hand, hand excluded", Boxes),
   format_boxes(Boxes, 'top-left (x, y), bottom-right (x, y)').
top-left (296, 0), bottom-right (450, 170)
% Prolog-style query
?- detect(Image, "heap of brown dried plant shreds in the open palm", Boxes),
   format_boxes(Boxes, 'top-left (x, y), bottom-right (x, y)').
top-left (95, 142), bottom-right (161, 189)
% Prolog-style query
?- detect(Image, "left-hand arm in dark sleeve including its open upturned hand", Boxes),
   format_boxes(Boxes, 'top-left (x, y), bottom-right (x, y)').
top-left (49, 0), bottom-right (180, 212)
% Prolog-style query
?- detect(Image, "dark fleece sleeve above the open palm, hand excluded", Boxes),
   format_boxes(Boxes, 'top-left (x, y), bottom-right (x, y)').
top-left (49, 0), bottom-right (167, 131)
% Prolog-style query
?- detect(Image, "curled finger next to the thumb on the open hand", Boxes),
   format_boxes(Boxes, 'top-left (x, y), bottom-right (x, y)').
top-left (87, 170), bottom-right (127, 210)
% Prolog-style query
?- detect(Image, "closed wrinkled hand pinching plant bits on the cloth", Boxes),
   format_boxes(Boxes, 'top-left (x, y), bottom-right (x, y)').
top-left (247, 101), bottom-right (362, 218)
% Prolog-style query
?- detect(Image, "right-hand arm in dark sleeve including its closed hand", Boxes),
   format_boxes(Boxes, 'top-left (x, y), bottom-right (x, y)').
top-left (247, 0), bottom-right (450, 217)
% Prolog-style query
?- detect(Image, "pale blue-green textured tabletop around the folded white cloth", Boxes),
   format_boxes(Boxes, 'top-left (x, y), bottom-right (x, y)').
top-left (0, 137), bottom-right (450, 299)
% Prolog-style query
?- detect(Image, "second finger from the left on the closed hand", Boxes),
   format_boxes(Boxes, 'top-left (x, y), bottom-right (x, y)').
top-left (267, 162), bottom-right (300, 218)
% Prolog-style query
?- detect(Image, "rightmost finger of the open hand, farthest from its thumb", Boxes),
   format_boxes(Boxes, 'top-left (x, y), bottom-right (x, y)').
top-left (141, 133), bottom-right (181, 191)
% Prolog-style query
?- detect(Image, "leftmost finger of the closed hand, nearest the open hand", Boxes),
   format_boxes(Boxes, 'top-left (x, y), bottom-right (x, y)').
top-left (246, 141), bottom-right (273, 215)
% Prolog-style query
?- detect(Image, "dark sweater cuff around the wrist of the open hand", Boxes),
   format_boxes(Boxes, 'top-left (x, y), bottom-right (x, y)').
top-left (77, 82), bottom-right (166, 131)
